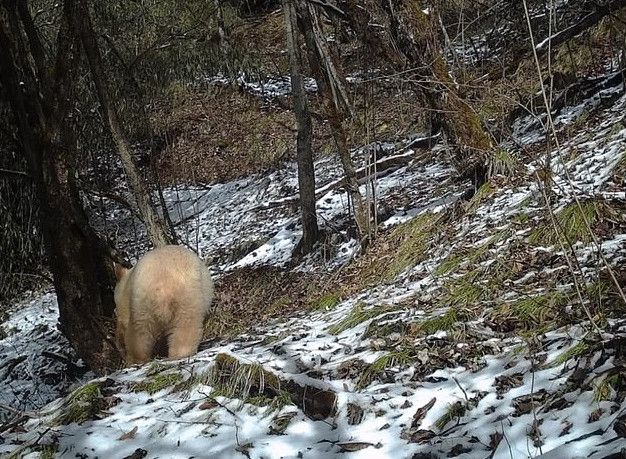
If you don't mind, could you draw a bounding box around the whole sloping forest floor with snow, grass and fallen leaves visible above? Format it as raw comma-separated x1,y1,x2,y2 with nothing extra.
0,50,626,459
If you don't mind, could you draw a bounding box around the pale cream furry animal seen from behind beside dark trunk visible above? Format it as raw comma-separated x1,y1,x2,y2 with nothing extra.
115,245,214,364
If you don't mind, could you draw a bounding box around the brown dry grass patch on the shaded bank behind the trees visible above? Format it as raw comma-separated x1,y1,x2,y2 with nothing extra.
154,87,295,183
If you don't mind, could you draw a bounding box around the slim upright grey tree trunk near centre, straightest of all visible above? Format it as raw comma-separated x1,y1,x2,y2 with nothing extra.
283,0,319,255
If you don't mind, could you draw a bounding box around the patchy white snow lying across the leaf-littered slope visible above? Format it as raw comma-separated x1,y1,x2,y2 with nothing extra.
0,74,626,459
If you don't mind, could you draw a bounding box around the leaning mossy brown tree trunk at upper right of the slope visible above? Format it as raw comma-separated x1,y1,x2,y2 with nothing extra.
340,0,491,187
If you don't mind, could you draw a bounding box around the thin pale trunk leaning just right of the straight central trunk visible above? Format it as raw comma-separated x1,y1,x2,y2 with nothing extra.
295,0,369,239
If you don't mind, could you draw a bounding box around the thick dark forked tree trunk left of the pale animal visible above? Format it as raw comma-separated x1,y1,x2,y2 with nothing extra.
0,3,119,371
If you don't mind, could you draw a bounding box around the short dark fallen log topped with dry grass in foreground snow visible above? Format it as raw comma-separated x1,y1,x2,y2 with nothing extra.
211,353,337,420
